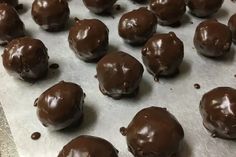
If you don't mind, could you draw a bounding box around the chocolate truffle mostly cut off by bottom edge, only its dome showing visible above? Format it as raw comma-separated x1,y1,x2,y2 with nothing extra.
58,135,118,157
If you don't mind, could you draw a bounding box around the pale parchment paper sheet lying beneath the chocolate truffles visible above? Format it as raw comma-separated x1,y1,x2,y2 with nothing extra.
0,0,236,157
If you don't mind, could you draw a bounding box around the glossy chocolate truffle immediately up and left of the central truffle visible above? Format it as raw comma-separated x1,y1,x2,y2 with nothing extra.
68,19,109,61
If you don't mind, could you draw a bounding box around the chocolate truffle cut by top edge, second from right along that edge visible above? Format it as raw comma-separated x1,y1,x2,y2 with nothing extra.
149,0,186,25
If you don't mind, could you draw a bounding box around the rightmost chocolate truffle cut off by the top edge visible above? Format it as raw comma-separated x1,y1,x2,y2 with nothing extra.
186,0,224,17
